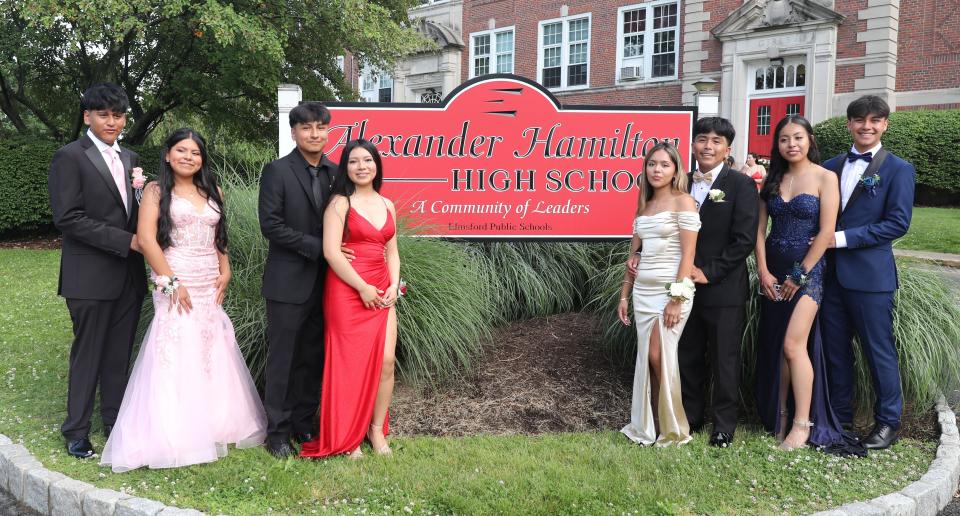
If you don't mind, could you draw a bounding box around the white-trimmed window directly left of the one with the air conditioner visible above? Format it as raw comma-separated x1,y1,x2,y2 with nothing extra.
537,13,590,89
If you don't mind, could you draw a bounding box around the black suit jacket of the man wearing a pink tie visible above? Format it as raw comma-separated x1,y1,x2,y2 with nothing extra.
47,135,147,300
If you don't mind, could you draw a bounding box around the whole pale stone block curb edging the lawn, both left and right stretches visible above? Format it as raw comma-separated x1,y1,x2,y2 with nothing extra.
0,402,960,516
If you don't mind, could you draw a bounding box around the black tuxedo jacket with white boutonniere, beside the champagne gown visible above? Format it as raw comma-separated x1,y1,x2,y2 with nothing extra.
690,165,759,306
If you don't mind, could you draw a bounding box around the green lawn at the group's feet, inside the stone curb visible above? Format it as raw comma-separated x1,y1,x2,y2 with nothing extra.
0,250,935,514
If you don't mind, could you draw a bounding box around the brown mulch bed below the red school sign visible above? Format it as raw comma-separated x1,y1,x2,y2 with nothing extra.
390,313,633,436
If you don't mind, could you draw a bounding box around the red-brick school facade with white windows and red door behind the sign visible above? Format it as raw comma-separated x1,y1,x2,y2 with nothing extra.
461,0,960,161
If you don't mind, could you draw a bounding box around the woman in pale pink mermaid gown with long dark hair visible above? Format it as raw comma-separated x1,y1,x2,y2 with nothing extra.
101,129,266,472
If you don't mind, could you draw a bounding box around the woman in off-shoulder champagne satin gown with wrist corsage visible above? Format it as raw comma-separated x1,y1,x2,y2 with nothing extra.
618,144,700,446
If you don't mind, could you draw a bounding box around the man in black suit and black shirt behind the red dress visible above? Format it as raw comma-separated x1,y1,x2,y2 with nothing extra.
259,102,337,458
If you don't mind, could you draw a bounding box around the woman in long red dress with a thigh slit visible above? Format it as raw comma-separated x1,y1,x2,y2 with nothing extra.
300,140,400,460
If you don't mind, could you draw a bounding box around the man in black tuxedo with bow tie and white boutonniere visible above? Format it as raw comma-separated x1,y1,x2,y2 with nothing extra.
678,117,758,447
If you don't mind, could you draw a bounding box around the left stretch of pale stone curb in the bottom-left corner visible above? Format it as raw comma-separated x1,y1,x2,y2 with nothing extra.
0,434,204,516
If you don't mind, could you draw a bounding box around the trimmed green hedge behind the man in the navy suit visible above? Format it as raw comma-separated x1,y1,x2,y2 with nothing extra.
814,109,960,204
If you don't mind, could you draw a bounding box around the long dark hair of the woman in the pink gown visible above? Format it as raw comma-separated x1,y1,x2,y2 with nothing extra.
157,127,227,254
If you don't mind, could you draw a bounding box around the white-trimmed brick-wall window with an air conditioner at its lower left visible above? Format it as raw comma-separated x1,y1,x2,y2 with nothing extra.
617,0,680,82
